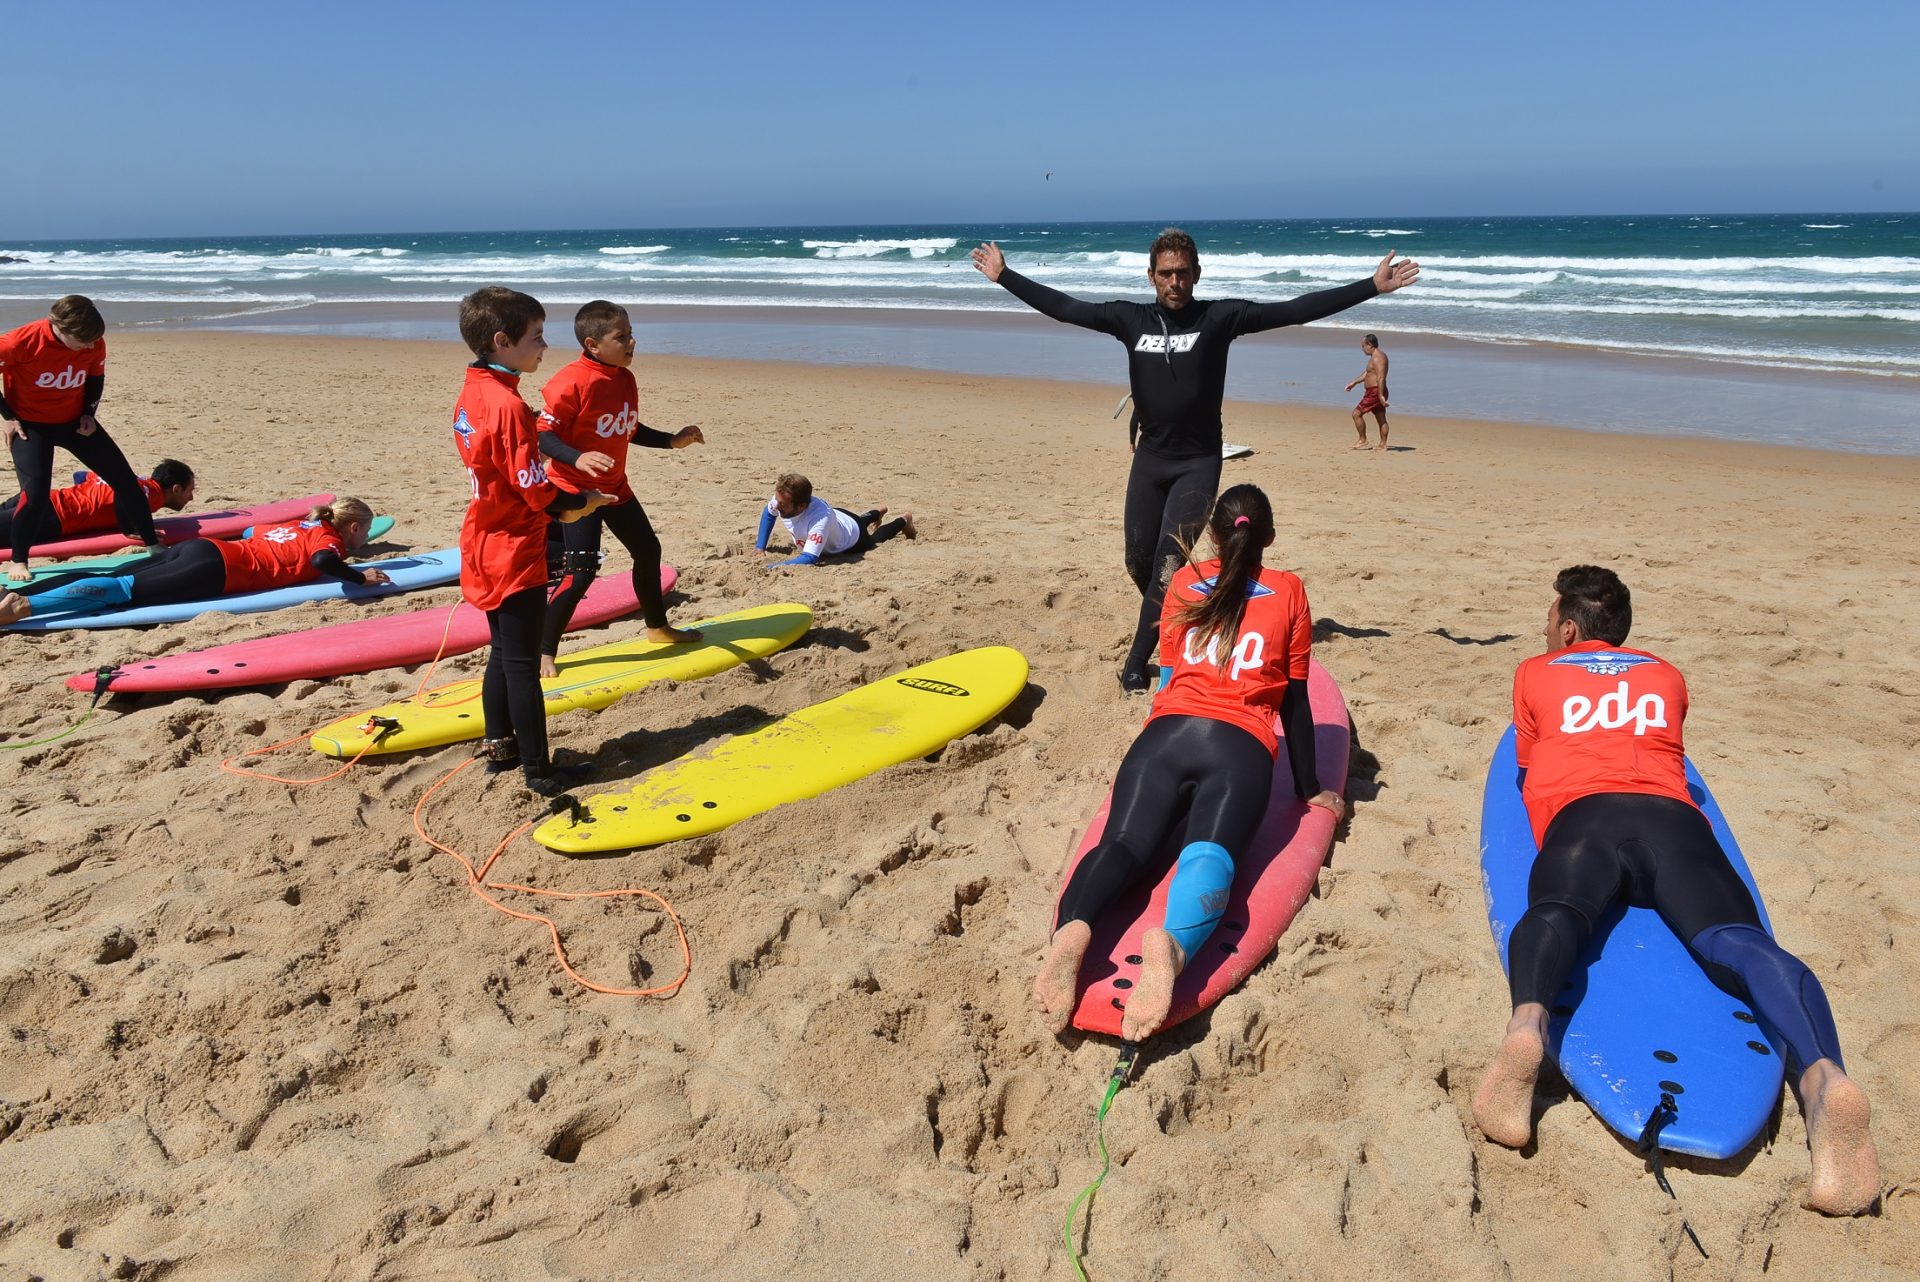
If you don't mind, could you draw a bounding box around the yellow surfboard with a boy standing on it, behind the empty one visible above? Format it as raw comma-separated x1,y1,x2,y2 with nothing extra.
311,603,814,758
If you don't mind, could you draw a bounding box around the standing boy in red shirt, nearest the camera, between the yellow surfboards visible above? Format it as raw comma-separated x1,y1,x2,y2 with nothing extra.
453,286,611,796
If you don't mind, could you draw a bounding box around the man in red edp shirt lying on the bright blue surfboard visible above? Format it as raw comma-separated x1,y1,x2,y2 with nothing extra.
1473,566,1880,1215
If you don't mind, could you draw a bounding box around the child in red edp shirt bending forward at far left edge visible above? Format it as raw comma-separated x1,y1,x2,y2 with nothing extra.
0,294,159,582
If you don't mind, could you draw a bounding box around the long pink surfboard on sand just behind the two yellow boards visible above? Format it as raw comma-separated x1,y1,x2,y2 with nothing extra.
67,564,680,695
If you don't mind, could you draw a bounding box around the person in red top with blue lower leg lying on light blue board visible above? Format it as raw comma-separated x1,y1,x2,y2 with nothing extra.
0,499,388,626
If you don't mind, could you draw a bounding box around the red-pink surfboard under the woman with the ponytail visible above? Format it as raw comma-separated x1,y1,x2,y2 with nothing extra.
1048,664,1352,1036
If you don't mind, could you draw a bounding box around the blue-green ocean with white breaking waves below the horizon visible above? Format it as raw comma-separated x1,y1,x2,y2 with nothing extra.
0,213,1920,382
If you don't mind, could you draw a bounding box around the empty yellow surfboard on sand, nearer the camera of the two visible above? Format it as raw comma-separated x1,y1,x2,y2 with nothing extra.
534,645,1027,854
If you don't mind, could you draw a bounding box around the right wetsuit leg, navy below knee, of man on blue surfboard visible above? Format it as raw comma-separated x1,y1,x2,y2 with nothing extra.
1628,796,1841,1077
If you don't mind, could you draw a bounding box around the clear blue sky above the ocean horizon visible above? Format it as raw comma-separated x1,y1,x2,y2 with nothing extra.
0,0,1920,240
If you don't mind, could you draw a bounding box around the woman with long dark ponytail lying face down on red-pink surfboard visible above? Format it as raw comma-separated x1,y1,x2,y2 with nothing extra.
1033,486,1346,1042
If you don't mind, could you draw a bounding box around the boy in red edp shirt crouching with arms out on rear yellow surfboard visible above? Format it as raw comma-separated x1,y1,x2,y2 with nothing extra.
540,299,707,677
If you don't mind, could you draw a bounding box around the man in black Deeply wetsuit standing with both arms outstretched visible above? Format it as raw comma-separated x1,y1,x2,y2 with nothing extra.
973,226,1421,691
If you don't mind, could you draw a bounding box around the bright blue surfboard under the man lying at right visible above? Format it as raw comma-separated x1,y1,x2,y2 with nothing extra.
1480,725,1786,1157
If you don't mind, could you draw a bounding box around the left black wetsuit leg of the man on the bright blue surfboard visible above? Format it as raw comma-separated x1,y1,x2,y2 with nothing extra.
1507,793,1626,1006
